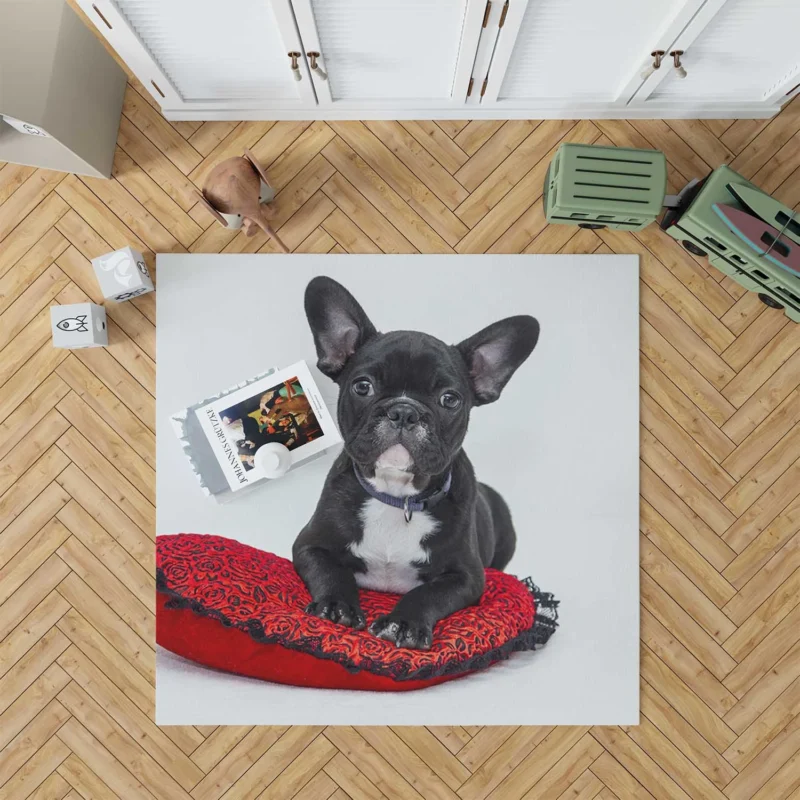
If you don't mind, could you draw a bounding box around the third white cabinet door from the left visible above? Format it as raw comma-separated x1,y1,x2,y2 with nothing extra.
475,0,703,110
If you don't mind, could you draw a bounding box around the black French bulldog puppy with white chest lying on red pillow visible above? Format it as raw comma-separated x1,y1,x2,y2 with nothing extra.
293,277,539,649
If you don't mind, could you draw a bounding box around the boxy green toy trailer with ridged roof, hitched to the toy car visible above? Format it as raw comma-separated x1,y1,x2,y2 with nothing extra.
544,144,667,231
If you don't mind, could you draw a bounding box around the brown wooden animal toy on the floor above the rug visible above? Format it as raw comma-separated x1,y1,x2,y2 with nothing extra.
198,150,289,253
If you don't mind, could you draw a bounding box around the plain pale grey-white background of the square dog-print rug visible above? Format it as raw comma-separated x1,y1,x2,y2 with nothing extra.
156,255,639,725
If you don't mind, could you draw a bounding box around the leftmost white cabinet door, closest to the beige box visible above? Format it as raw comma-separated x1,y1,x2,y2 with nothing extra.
79,0,316,110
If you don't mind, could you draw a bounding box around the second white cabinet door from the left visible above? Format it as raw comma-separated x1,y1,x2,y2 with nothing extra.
292,0,486,110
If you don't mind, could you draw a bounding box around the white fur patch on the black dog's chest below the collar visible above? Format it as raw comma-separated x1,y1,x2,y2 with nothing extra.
350,497,439,594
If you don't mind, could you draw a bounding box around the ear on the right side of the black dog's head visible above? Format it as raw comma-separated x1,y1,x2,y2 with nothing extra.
457,315,539,406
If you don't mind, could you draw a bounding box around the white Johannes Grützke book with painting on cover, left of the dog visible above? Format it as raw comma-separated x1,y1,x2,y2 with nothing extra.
194,361,341,492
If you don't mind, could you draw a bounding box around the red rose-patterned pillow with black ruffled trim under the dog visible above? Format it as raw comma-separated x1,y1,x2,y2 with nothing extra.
156,533,558,691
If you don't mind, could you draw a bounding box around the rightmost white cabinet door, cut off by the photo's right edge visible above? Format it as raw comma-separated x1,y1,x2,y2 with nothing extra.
635,0,800,107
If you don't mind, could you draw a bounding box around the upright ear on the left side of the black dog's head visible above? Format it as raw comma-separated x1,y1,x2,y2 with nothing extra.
305,276,377,380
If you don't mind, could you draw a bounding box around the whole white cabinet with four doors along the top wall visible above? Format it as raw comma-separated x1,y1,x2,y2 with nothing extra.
77,0,800,119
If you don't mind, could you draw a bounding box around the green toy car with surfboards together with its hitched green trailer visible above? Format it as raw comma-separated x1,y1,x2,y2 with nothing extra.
543,144,800,322
